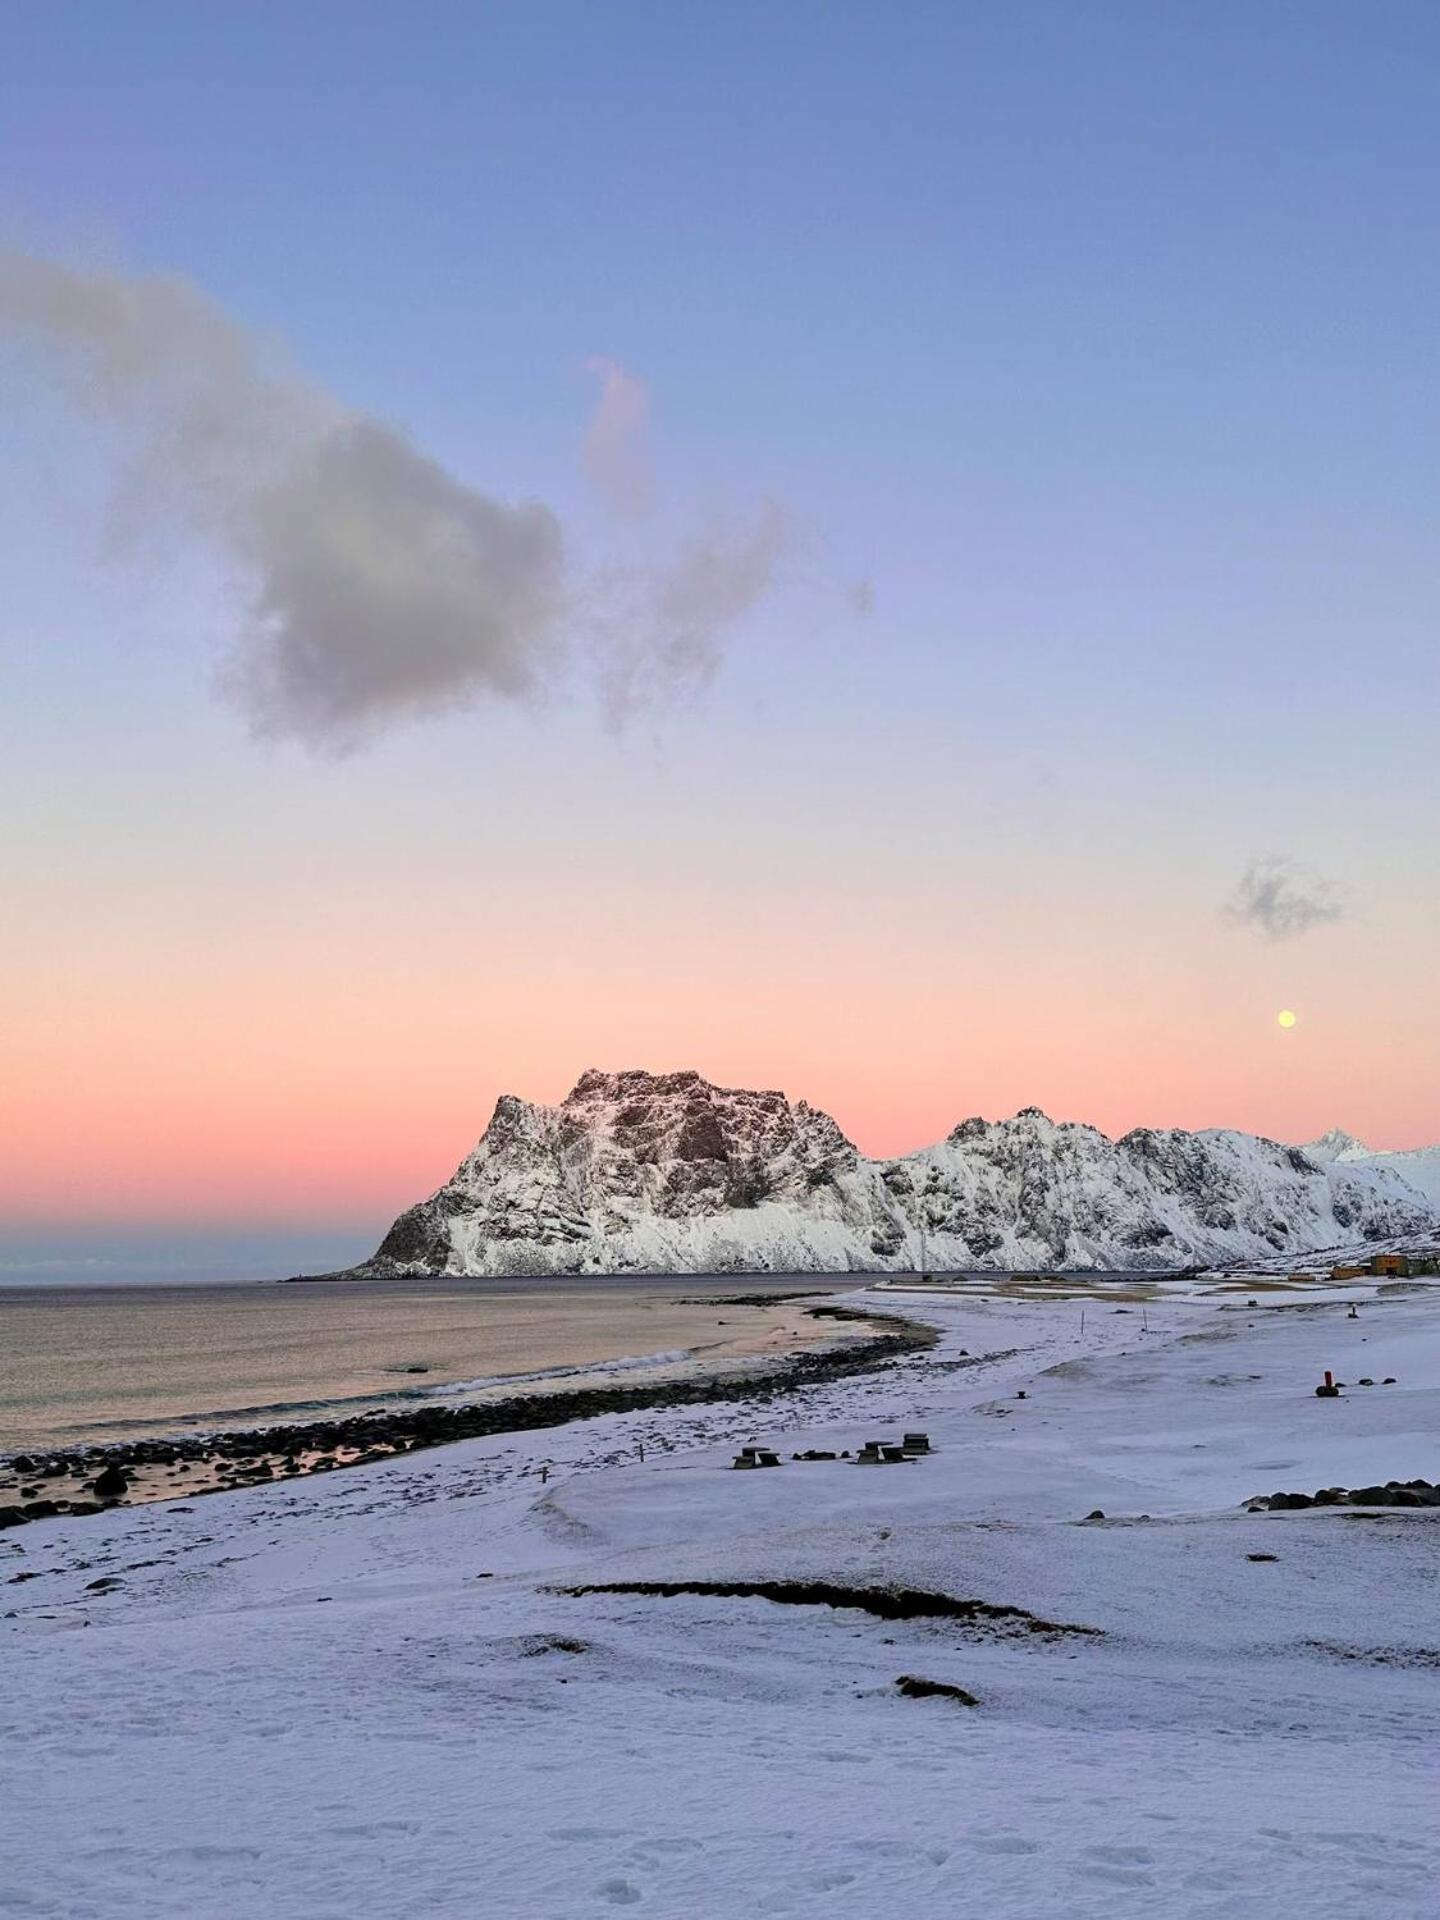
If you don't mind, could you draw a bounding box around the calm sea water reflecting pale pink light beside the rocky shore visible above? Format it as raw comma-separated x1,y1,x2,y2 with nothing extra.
0,1275,860,1450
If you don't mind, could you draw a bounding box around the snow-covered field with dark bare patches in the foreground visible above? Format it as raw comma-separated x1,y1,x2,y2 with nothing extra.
0,1288,1440,1920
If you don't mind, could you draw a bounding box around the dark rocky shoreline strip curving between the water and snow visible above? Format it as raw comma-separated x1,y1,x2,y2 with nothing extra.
0,1306,939,1528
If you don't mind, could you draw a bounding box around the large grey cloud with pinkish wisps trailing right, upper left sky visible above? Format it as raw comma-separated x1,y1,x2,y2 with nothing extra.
0,253,781,751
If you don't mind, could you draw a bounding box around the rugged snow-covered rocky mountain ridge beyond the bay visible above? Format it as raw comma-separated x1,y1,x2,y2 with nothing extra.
341,1069,1440,1277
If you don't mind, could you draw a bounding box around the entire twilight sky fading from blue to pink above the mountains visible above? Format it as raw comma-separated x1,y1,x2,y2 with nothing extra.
0,0,1440,1277
